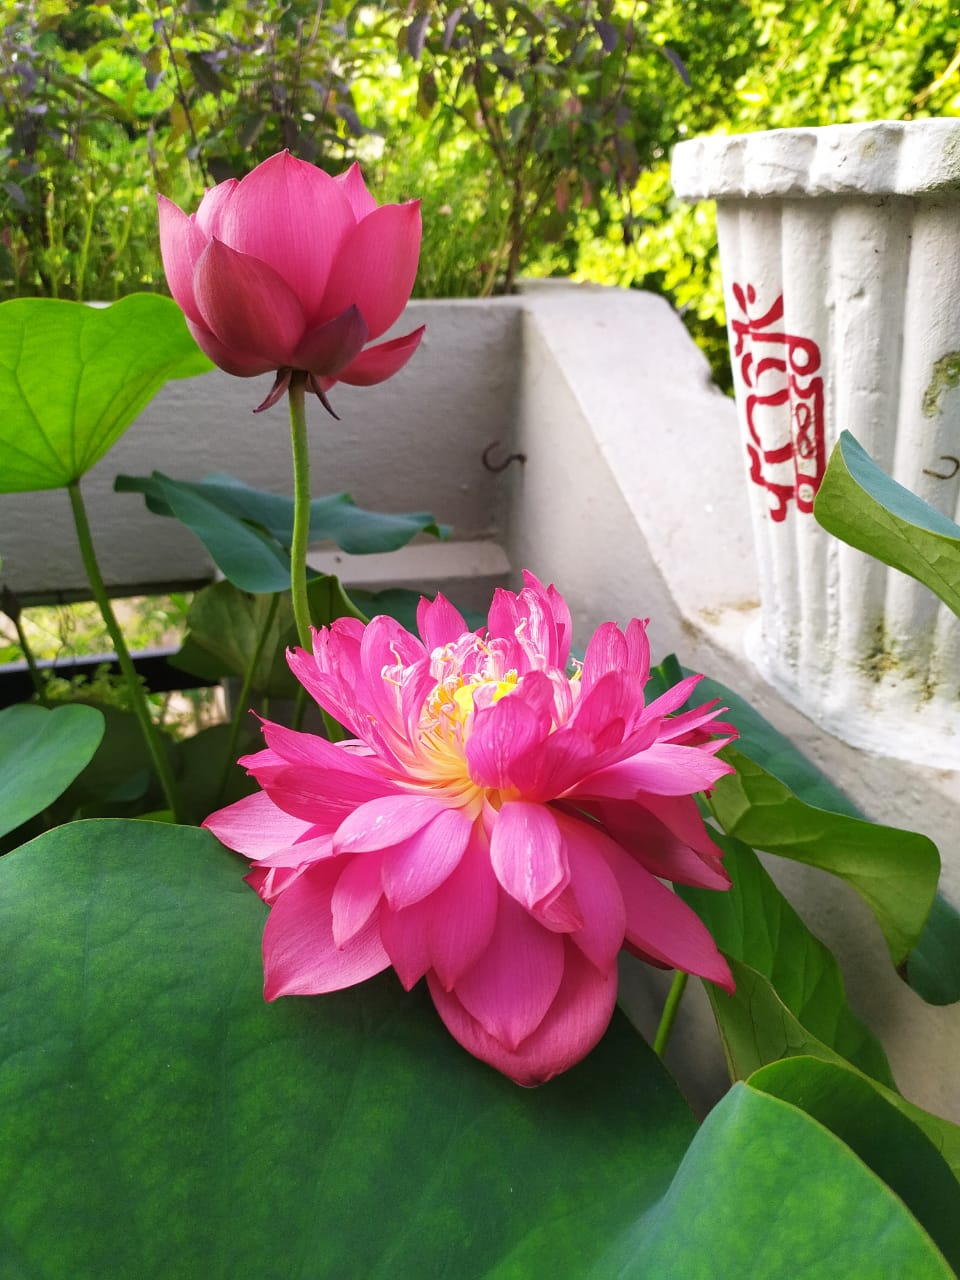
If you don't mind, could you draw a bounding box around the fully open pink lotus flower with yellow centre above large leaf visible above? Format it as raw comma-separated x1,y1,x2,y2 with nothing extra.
205,573,733,1084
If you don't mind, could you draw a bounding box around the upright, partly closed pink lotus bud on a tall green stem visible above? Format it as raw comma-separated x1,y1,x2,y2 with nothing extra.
157,151,424,410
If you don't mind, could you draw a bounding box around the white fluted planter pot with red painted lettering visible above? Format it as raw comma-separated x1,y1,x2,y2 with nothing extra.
673,119,960,768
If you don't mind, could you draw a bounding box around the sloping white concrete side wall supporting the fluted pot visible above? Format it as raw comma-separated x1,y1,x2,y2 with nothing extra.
507,288,960,1121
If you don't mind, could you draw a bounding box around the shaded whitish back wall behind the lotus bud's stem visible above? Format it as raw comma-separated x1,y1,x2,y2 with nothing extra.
0,300,521,603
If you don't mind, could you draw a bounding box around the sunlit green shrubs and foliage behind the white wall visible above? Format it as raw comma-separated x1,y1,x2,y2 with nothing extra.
0,0,960,379
